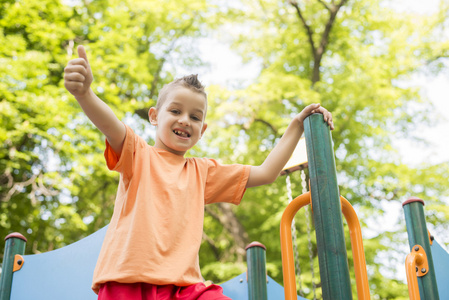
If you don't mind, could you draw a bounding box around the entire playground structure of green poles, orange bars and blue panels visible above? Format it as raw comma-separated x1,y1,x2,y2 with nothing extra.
0,114,449,300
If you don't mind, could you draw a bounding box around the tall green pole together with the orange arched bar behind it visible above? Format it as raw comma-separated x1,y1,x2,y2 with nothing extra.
281,114,369,300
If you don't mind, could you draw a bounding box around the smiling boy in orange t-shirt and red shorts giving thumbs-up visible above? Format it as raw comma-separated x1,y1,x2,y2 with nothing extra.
64,46,333,300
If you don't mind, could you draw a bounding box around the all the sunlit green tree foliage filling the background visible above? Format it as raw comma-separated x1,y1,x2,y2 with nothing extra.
0,0,449,299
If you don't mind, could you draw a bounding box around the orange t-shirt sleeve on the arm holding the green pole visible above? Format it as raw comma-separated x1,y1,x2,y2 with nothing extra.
204,159,251,204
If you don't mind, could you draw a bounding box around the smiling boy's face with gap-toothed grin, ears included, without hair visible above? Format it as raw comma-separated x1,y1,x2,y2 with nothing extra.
148,87,207,155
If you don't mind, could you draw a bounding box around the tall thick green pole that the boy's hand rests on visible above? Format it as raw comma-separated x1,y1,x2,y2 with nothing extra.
304,114,352,300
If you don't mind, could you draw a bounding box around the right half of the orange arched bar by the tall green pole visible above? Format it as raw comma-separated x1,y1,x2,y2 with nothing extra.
340,196,370,300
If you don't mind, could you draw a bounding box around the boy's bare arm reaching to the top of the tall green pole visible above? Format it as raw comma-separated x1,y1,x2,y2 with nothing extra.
246,104,334,187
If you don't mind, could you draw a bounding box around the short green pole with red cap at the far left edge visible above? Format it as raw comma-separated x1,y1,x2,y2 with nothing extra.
0,232,27,300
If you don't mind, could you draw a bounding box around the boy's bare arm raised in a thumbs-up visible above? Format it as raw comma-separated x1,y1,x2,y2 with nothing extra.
64,46,126,155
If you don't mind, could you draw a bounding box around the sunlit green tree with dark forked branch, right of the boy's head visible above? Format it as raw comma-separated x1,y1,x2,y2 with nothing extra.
199,0,449,299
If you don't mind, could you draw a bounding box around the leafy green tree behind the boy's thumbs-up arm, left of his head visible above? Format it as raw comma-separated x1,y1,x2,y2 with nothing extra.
0,0,213,253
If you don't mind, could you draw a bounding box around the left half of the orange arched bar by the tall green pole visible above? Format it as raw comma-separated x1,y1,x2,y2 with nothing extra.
281,192,311,300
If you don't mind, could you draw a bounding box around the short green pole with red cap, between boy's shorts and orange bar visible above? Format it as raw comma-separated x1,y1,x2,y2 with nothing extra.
246,242,268,300
